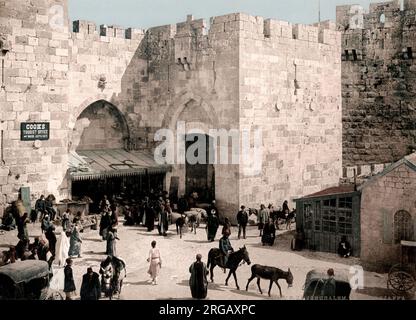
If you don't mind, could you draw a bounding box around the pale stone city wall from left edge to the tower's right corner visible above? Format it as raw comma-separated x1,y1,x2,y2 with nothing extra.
0,0,341,216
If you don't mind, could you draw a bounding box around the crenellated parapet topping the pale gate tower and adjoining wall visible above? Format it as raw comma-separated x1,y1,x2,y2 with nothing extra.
73,12,340,45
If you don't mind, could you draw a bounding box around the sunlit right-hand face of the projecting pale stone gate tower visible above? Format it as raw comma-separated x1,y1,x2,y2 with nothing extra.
240,16,342,207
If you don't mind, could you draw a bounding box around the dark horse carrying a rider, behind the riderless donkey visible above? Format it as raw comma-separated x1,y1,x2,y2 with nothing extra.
207,246,251,290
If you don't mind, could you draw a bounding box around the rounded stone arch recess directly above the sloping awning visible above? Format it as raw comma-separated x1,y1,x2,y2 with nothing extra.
69,99,130,151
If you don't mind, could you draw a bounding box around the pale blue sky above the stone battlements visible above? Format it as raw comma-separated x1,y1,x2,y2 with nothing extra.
68,0,383,29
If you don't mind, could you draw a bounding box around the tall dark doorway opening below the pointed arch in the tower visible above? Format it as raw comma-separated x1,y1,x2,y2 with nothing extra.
185,134,215,203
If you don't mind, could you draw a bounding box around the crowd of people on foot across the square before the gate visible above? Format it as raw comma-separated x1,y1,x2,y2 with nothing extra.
1,190,351,300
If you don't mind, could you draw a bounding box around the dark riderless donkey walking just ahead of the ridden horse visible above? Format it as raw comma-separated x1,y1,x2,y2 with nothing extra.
246,264,293,297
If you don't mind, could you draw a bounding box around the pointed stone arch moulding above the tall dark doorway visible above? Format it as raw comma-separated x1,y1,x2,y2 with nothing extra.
162,90,219,130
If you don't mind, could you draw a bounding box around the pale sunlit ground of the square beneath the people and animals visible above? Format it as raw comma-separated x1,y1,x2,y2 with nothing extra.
0,220,398,300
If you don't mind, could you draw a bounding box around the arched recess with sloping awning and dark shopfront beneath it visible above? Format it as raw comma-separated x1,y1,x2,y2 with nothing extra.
69,100,168,212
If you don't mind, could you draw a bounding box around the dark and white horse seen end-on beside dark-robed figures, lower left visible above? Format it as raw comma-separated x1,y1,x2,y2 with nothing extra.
100,256,127,300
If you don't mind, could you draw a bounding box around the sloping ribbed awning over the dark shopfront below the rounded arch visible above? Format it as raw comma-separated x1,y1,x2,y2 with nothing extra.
68,149,170,181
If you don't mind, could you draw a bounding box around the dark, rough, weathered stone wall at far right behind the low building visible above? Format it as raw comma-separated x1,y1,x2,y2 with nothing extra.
337,0,416,166
